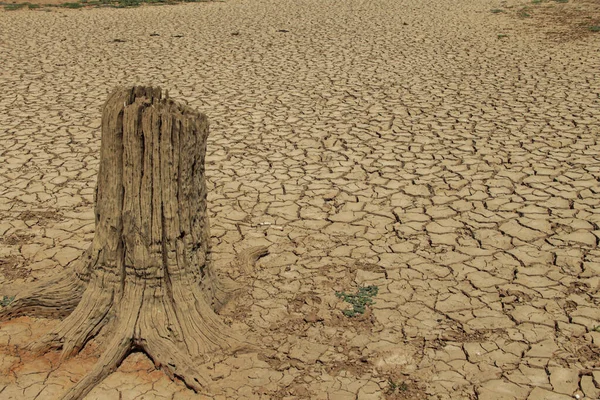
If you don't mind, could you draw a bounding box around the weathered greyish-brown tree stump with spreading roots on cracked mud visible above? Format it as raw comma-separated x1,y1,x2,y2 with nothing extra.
0,87,266,400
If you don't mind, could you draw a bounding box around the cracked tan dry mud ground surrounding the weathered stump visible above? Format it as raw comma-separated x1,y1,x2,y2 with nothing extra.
0,0,600,400
